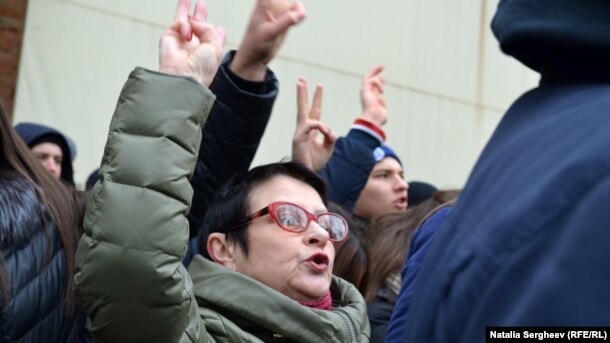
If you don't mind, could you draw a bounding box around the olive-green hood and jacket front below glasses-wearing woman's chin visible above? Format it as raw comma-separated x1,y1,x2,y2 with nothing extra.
189,255,370,343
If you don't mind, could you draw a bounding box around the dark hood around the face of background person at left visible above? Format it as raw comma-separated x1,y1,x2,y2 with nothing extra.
15,123,76,185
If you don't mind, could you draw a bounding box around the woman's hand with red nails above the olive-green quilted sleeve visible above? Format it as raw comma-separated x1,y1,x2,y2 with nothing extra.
159,0,225,87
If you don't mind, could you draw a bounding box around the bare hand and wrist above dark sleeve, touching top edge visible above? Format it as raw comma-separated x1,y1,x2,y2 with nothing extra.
230,0,305,81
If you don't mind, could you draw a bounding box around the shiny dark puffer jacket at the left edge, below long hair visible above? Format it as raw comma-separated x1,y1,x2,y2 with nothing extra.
0,171,84,343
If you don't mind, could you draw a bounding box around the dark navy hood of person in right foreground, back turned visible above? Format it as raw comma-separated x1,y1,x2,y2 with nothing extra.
491,0,610,75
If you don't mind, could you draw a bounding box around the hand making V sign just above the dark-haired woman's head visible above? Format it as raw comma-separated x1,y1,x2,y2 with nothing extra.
292,77,337,171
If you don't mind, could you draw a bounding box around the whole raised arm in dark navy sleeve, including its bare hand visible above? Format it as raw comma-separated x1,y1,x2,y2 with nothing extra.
188,0,305,241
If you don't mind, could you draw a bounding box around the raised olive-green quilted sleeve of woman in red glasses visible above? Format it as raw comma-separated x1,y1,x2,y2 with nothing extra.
75,68,214,343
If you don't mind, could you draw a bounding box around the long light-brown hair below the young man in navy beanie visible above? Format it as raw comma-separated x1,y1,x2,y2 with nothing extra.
364,190,459,302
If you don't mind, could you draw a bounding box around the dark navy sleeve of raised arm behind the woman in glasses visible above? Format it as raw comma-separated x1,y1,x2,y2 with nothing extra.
185,51,278,265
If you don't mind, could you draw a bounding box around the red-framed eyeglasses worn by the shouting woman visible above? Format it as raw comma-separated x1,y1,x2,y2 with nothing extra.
231,201,348,242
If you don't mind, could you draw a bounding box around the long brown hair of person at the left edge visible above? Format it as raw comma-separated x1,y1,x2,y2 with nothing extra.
0,104,83,311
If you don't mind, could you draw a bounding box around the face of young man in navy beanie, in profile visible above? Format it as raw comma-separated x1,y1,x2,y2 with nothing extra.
354,157,409,220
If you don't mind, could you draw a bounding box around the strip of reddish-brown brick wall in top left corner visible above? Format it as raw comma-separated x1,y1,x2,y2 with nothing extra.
0,0,28,118
